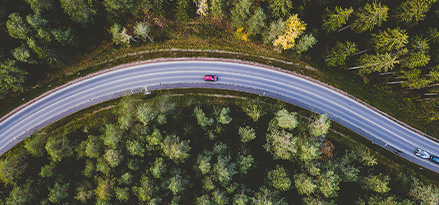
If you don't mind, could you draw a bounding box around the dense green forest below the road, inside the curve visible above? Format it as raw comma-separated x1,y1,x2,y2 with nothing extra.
0,94,439,204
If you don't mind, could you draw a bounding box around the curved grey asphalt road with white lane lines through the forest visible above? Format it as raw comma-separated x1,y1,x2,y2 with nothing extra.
0,59,439,173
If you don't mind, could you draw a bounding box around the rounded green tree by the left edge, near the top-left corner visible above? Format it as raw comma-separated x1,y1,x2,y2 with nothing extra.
6,12,31,40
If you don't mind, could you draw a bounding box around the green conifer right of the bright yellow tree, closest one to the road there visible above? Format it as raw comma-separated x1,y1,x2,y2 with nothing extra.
325,41,358,67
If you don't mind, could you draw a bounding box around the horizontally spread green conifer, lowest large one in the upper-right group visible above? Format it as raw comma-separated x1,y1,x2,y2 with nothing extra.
358,52,400,74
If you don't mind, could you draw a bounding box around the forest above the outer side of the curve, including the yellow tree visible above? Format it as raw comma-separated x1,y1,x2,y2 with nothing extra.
0,0,439,137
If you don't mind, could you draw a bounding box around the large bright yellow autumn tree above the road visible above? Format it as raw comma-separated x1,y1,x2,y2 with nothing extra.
273,14,306,50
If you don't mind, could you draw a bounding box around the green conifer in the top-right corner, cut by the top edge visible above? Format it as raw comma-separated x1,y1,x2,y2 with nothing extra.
395,0,436,26
